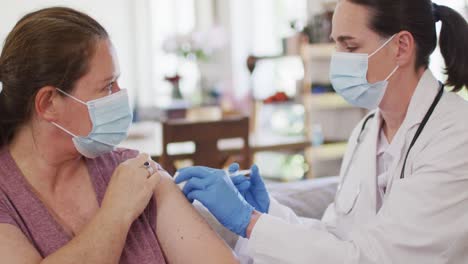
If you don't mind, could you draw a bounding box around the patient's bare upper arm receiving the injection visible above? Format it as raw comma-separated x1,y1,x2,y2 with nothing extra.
154,174,238,264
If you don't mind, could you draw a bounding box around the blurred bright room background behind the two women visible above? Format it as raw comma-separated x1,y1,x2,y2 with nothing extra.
0,0,468,182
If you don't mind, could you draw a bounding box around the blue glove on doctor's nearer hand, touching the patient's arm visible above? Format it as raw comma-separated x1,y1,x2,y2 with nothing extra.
175,167,254,237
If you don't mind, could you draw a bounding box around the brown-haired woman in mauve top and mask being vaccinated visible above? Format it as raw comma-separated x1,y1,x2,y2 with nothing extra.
0,8,236,264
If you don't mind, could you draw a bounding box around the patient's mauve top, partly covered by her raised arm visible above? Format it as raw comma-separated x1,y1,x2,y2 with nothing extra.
0,148,165,264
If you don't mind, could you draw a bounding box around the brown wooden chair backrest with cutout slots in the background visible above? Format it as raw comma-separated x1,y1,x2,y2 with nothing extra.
160,117,251,174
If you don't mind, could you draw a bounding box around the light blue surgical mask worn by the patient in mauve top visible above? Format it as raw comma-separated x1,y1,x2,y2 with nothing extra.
52,89,132,159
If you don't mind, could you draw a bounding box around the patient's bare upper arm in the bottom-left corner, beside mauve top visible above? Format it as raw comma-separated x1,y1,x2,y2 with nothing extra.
0,223,42,264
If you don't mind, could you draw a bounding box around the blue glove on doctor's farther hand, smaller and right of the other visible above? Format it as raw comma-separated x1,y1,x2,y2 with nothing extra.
229,163,270,214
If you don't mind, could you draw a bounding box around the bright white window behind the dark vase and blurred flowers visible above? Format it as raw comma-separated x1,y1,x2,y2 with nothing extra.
136,0,198,107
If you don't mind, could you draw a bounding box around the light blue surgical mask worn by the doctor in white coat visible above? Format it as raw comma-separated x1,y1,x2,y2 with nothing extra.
330,35,399,110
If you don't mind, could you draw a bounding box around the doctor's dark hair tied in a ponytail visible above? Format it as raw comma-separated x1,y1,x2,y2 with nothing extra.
347,0,468,92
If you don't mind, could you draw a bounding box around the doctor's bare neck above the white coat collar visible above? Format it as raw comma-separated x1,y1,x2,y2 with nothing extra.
379,68,425,143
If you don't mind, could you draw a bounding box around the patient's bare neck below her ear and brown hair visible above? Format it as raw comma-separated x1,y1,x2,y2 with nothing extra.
9,122,83,193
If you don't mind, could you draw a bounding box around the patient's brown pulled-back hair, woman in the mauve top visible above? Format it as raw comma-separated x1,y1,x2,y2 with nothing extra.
0,7,108,148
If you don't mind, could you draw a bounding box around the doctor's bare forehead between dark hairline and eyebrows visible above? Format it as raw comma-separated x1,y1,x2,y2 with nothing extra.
330,0,372,41
